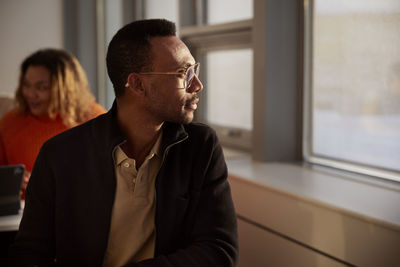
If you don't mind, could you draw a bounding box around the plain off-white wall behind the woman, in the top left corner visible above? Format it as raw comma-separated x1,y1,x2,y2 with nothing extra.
0,0,63,95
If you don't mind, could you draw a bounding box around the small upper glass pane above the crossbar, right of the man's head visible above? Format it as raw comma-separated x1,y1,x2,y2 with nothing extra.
207,0,253,24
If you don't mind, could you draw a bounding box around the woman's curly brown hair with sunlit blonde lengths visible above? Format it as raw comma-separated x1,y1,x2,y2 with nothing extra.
15,49,95,127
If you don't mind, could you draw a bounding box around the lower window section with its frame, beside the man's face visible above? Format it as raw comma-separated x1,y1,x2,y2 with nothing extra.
199,48,253,150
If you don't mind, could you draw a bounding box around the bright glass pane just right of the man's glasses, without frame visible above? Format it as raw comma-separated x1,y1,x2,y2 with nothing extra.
205,49,253,130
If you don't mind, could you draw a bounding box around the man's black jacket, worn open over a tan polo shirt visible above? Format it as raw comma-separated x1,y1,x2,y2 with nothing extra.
10,103,238,267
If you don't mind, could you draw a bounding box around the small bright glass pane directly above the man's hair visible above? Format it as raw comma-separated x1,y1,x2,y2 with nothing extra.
144,0,178,24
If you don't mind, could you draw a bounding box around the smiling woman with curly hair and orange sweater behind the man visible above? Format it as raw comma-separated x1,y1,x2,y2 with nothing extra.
0,49,105,198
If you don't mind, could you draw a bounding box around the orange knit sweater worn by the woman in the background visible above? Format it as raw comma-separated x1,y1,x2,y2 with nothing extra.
0,104,105,172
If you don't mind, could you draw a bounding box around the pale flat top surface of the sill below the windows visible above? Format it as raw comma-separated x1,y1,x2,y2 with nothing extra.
224,148,400,231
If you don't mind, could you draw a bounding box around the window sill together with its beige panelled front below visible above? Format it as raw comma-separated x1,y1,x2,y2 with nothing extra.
224,149,400,266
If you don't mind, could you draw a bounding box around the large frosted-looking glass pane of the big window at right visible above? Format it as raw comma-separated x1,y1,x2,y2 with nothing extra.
312,0,400,171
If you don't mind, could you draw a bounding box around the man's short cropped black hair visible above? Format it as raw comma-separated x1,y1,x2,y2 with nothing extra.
106,19,176,97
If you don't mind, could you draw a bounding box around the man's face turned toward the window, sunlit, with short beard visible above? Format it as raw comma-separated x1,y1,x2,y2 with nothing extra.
143,36,203,123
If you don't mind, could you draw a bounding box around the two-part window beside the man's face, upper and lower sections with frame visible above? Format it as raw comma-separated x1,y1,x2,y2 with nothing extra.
180,0,253,150
